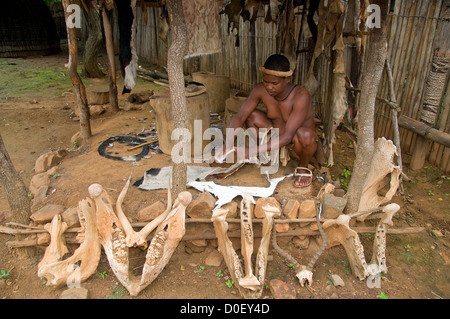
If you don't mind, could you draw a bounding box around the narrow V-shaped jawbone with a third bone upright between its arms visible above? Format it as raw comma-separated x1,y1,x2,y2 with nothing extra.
212,196,281,298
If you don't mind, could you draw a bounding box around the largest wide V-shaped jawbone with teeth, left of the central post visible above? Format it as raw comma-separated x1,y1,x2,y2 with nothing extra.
89,184,192,296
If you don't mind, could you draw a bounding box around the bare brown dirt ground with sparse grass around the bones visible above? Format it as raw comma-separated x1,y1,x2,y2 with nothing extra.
0,53,450,299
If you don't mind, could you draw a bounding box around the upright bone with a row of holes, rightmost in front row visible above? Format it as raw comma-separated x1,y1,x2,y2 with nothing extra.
371,204,400,273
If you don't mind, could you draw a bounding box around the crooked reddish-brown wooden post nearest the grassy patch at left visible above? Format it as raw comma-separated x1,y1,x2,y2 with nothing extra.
62,0,92,140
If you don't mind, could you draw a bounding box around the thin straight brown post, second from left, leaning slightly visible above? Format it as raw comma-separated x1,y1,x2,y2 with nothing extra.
102,6,119,113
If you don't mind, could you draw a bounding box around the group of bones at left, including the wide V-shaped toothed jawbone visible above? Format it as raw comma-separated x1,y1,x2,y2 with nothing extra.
38,179,192,296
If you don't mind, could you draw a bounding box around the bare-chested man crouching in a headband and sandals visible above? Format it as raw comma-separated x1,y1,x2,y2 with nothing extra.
218,54,317,187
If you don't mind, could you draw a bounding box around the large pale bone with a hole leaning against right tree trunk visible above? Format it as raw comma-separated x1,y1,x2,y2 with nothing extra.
357,137,401,221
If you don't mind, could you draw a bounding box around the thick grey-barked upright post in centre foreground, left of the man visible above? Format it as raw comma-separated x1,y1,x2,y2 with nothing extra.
166,0,189,198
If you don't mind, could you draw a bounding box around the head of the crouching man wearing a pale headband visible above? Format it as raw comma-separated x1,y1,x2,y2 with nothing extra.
259,54,293,97
